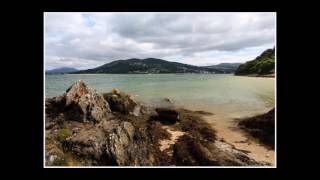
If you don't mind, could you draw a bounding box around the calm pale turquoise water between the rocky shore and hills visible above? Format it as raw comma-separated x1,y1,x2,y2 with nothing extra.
45,74,275,115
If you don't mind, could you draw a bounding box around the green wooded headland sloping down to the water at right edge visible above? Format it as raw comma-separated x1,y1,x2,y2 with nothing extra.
235,48,275,75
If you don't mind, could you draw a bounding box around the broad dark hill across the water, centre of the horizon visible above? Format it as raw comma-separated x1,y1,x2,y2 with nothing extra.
72,58,239,74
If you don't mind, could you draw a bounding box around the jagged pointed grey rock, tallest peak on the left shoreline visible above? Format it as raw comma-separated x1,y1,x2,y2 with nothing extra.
46,80,112,125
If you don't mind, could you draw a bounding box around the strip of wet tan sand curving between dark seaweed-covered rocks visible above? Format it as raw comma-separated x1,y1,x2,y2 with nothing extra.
204,114,275,165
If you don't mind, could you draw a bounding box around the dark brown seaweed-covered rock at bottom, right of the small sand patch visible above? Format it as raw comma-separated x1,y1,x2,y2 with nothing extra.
174,135,267,166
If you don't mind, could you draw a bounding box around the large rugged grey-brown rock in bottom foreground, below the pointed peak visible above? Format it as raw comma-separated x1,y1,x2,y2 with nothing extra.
63,120,153,166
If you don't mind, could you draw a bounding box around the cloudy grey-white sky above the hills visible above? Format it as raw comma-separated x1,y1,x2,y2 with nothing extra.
44,12,276,70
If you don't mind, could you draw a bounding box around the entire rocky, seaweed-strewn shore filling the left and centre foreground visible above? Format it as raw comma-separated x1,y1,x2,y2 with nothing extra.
45,81,263,166
